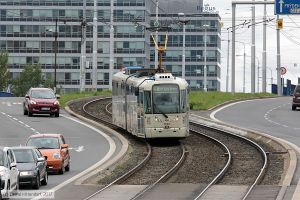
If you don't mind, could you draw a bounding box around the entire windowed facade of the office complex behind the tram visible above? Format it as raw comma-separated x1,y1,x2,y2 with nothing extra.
0,0,220,92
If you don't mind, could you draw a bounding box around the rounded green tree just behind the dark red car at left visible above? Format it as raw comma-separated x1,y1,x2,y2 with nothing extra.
12,65,43,96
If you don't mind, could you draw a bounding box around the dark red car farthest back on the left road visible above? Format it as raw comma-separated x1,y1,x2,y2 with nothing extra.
23,88,60,117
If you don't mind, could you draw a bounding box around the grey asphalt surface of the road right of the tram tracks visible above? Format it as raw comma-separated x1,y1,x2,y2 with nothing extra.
214,97,300,146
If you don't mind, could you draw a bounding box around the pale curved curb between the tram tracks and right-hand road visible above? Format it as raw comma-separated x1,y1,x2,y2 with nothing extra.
190,114,300,200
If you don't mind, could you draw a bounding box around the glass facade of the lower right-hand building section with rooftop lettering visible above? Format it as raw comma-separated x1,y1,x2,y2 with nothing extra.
150,12,221,91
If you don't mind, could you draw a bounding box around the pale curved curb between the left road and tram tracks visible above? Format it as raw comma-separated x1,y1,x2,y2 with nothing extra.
65,106,129,185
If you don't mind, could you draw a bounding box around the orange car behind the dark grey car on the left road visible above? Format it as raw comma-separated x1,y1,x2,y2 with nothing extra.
26,134,70,174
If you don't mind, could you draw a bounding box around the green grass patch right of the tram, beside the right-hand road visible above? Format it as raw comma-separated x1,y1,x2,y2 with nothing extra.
189,92,275,110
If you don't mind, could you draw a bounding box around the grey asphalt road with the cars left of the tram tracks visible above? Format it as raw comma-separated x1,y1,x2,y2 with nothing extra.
0,98,114,197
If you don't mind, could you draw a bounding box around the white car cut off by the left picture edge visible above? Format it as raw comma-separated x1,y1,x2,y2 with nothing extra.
0,147,19,198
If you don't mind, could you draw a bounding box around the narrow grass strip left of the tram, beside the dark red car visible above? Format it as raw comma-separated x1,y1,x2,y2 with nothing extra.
59,90,111,108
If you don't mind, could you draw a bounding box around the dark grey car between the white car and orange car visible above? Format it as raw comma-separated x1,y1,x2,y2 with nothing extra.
11,146,48,190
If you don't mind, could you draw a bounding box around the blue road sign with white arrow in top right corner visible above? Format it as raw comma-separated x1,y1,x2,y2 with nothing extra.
274,0,300,15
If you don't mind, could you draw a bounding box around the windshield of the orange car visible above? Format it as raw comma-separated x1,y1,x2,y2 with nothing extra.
27,137,59,149
